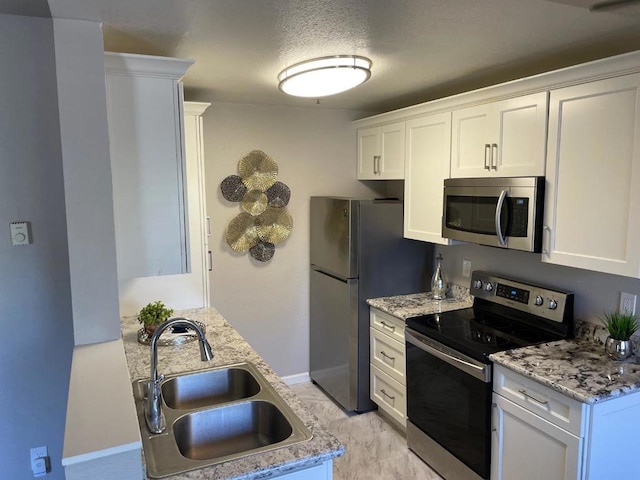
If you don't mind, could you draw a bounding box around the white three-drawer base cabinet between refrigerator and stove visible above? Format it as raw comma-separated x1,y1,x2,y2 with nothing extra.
369,307,407,429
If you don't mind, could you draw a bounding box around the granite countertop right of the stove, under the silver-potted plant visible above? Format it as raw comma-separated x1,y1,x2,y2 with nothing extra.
489,339,640,404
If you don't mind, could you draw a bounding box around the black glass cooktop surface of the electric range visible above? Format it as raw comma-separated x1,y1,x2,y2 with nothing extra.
407,308,564,362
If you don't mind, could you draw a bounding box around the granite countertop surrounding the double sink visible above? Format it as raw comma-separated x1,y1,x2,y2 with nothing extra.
122,308,345,480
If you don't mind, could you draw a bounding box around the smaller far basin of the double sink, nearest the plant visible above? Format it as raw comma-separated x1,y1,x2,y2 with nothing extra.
162,367,260,410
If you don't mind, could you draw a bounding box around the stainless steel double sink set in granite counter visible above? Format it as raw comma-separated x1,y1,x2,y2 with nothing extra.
133,362,311,478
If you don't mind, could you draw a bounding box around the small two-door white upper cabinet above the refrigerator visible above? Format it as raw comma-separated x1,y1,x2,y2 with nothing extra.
358,122,404,180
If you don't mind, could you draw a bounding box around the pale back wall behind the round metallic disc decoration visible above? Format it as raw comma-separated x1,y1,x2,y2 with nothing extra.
204,103,384,375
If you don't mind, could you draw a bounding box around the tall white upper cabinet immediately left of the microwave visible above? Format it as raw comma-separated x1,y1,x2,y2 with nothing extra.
404,112,451,244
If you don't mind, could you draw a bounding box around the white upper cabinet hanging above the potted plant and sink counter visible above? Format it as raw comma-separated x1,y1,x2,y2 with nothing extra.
105,53,193,279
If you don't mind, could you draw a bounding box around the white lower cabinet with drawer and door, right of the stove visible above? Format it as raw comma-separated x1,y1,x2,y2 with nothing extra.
491,365,640,480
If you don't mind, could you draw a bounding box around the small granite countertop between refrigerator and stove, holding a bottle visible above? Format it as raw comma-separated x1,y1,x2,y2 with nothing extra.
367,285,473,320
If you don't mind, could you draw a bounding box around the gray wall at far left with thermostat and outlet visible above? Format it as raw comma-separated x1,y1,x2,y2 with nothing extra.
0,15,74,480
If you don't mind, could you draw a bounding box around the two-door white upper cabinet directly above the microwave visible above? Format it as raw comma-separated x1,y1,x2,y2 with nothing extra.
451,92,548,178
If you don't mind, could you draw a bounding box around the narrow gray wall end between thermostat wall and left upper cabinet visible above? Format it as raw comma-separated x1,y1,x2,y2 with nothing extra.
53,19,120,345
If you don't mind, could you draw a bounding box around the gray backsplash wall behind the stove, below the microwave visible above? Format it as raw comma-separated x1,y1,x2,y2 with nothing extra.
435,244,640,323
